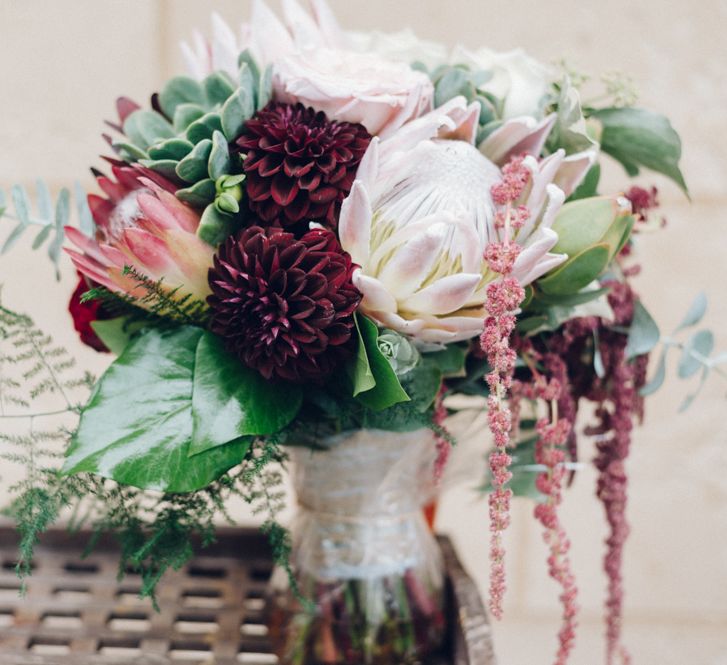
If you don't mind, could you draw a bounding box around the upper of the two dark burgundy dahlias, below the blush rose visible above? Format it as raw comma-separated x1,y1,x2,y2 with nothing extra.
237,102,371,229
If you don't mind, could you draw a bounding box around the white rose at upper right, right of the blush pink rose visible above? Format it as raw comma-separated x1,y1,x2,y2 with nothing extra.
451,46,554,119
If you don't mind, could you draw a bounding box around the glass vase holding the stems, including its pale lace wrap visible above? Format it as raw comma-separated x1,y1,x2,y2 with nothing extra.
269,430,444,665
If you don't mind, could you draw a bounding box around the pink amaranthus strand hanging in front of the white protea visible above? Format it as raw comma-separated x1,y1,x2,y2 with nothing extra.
480,158,529,619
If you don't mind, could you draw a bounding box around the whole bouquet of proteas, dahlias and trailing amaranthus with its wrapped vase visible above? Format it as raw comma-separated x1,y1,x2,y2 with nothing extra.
0,0,712,663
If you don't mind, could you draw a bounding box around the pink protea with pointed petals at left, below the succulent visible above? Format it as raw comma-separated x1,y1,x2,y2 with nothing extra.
66,164,214,304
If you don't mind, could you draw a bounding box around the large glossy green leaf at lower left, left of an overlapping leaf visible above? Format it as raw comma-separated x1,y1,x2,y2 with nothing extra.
63,326,250,492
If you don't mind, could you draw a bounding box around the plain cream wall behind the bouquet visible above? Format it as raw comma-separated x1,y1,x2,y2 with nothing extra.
0,0,727,665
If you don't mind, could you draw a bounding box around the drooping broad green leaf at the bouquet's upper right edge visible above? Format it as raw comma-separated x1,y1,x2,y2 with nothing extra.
592,107,687,193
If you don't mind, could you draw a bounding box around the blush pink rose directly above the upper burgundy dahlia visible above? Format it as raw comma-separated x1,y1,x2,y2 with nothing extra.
273,48,434,137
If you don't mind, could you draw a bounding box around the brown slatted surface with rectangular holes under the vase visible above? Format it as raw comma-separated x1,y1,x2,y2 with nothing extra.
0,529,494,665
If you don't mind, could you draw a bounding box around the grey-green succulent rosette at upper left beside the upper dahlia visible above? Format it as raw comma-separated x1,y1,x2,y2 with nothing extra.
113,52,272,245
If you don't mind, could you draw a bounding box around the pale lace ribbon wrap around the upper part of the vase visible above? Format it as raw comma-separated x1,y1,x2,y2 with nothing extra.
291,430,440,581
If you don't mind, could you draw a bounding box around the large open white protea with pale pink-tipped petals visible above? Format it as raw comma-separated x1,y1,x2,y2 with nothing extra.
339,97,594,344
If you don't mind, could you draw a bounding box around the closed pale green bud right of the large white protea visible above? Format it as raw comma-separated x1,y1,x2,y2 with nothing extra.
537,196,635,296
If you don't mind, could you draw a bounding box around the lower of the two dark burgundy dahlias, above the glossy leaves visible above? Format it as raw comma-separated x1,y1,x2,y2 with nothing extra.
208,226,361,382
